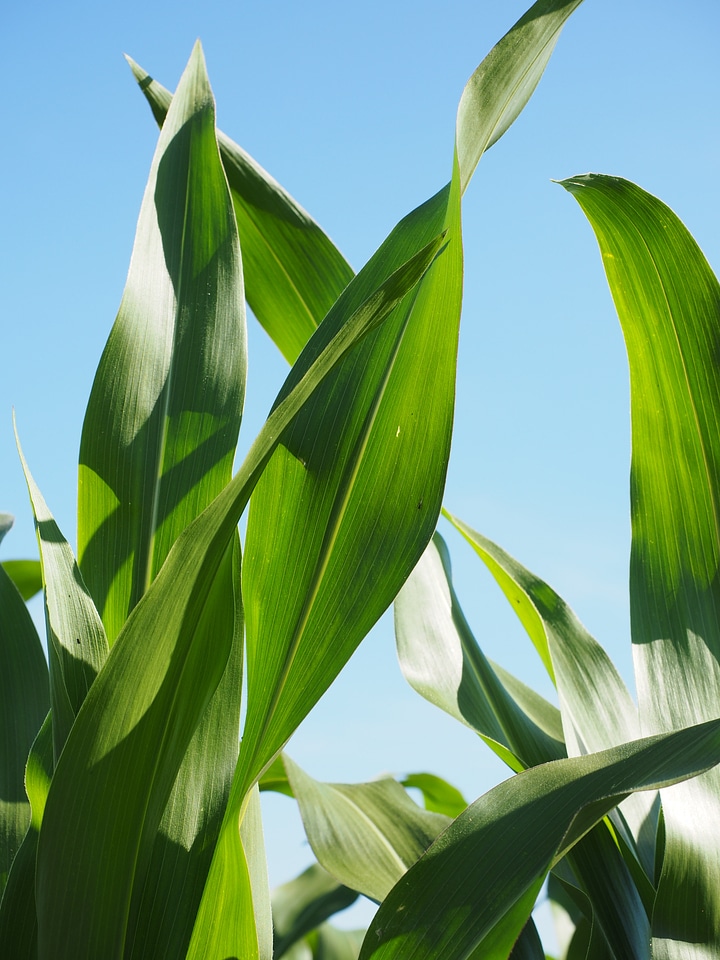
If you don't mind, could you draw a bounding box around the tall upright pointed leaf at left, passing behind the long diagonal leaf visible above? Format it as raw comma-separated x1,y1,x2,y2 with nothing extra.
79,39,247,960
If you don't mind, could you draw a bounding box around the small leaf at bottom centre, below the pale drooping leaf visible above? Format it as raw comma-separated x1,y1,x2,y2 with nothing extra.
272,863,358,958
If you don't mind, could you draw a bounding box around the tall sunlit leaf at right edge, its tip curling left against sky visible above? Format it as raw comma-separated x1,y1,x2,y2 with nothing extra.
563,175,720,960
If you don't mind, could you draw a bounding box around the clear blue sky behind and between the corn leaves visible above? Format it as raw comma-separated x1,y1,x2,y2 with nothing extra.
0,0,720,944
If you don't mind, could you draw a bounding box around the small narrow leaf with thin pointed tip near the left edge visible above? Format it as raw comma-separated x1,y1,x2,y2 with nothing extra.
15,433,108,761
